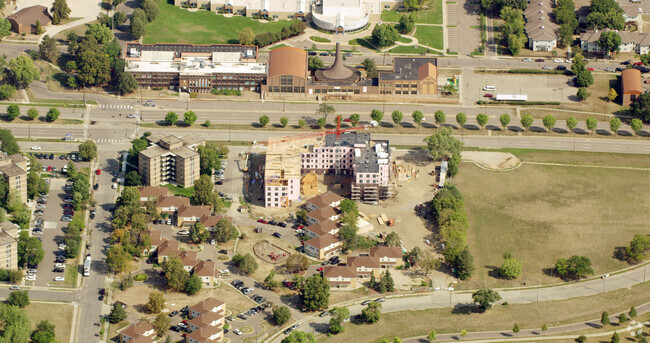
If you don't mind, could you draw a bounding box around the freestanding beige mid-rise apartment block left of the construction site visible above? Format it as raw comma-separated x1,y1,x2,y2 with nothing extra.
138,134,205,187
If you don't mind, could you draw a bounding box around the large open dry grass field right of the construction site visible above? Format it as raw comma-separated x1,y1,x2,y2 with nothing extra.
454,163,650,289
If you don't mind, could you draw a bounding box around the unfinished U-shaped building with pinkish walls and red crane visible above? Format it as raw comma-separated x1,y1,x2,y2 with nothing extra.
264,132,392,207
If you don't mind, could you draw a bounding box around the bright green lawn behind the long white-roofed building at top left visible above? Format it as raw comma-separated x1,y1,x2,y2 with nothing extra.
144,2,291,44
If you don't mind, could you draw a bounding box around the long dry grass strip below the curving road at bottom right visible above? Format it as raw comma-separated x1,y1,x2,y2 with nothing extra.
319,283,650,342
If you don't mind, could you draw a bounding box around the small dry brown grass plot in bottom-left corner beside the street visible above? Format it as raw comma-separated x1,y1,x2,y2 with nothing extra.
25,302,74,343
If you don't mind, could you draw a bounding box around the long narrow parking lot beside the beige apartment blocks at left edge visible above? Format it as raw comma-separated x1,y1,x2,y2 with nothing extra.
30,152,90,287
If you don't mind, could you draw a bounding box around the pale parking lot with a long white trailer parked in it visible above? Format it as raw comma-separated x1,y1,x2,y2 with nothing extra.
463,69,577,104
